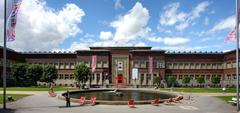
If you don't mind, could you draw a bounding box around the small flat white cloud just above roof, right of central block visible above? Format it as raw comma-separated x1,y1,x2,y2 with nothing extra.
148,37,190,45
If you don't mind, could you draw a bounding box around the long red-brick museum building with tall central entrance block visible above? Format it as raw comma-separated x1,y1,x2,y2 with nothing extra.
0,47,236,86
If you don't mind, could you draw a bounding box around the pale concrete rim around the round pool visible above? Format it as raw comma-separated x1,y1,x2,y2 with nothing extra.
58,88,177,105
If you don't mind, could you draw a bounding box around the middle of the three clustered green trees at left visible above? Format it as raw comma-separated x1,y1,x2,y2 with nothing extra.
26,64,43,86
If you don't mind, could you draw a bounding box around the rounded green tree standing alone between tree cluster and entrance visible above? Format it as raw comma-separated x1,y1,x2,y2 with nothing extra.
74,64,91,87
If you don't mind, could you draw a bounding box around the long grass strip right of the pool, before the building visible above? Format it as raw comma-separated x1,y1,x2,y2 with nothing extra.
160,88,236,93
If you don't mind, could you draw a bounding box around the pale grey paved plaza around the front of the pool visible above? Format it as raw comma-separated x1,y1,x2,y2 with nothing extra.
0,92,236,113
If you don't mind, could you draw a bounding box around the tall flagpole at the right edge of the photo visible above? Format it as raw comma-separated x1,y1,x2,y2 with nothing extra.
236,0,239,111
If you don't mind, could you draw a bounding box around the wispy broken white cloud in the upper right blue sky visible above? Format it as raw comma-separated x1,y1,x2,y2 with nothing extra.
158,1,209,31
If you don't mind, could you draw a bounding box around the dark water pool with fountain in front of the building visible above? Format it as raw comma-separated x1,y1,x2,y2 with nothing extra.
61,88,176,105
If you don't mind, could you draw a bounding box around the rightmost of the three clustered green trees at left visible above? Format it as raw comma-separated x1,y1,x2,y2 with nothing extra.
40,65,57,83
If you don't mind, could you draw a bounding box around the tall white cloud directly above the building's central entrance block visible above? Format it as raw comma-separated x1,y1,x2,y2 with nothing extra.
110,2,151,42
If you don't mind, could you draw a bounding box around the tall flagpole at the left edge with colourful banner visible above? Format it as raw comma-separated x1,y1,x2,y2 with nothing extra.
3,0,7,109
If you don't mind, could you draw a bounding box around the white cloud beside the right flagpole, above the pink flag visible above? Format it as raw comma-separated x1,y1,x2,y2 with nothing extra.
209,15,235,33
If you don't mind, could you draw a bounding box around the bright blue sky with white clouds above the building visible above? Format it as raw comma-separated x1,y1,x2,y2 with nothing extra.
0,0,235,51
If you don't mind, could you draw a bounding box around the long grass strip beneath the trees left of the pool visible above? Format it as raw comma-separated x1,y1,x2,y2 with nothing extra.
0,86,76,91
